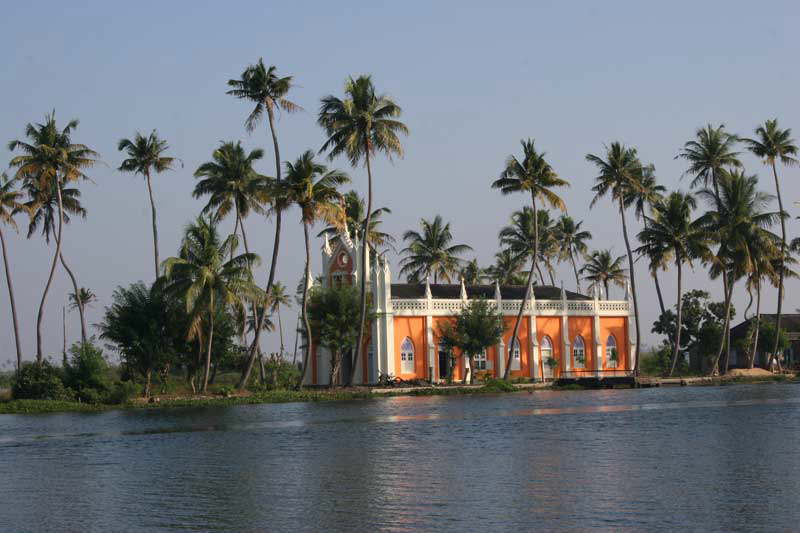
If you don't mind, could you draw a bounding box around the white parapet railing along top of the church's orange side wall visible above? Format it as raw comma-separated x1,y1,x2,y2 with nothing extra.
391,298,630,316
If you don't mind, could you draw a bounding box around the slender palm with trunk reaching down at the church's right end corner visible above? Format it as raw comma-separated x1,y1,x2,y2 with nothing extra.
586,142,642,375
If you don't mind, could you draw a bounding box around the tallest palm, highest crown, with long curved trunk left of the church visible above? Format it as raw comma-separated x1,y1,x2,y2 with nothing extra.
226,58,302,389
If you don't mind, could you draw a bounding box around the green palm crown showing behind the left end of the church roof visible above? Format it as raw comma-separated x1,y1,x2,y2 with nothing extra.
400,215,472,283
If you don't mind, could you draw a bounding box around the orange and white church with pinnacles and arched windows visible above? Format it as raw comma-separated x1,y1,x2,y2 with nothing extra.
306,227,635,385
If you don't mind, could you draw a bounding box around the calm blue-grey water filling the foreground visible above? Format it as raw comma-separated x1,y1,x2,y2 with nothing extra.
0,385,800,531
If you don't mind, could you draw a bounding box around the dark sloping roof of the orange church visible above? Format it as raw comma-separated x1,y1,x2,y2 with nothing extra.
392,283,591,300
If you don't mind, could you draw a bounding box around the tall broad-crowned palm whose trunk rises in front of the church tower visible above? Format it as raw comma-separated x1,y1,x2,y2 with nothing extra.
317,76,408,382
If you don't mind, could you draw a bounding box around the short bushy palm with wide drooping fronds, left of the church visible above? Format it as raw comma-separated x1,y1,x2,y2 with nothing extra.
163,216,263,392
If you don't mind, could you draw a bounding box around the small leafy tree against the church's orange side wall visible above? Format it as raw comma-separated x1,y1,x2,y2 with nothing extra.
439,299,505,383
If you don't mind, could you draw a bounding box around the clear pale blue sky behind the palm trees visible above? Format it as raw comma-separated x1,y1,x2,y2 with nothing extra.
0,1,800,361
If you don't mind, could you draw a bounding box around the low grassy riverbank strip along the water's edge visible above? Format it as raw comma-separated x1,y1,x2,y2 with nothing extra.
0,374,800,415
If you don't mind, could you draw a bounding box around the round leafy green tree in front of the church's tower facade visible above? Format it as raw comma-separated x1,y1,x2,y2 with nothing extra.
308,285,373,387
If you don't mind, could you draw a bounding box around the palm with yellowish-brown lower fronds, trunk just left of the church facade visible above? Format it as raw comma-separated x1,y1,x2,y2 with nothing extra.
284,150,350,385
